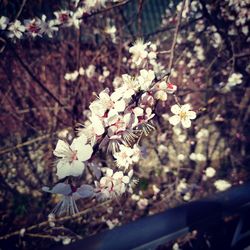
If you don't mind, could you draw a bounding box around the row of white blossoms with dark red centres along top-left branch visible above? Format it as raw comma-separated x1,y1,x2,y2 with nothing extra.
0,0,116,40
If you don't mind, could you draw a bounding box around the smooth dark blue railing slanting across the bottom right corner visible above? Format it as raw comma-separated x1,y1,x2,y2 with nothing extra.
56,183,250,250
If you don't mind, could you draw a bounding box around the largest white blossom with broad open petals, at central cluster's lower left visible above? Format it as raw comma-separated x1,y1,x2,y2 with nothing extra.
53,135,93,179
